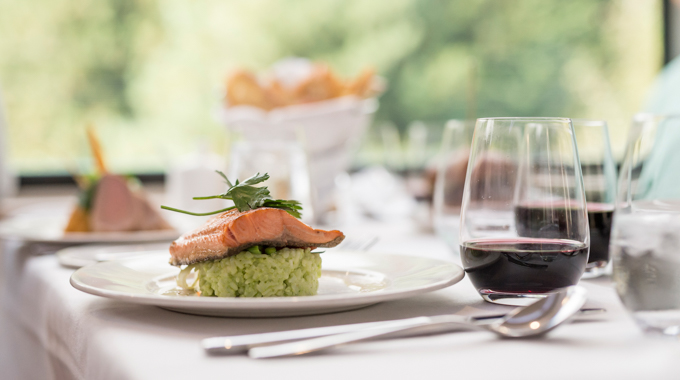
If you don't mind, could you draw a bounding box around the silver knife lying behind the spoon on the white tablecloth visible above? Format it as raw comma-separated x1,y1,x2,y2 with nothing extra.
201,296,606,355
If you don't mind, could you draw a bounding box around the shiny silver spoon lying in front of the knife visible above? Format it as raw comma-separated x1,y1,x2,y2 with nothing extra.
248,286,586,359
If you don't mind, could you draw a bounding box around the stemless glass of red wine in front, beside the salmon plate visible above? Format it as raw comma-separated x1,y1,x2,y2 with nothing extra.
460,118,590,305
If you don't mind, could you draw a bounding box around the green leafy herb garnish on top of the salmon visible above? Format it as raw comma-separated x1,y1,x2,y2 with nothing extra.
161,170,302,219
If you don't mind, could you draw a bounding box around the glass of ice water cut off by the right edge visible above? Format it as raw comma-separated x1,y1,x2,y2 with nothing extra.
610,115,680,336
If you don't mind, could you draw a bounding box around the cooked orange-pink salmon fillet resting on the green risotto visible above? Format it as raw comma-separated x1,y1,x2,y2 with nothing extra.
170,207,345,265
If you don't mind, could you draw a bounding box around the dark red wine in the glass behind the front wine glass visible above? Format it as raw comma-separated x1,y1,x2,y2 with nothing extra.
515,203,614,267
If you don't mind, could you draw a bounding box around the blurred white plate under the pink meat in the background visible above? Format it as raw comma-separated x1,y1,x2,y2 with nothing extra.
0,214,179,244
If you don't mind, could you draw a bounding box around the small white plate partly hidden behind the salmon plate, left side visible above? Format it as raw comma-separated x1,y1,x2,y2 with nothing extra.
56,242,170,268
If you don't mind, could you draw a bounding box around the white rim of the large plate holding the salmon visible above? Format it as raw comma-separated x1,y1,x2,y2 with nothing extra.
69,251,465,311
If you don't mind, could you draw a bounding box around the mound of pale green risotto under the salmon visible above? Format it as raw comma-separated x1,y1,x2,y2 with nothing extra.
178,248,321,297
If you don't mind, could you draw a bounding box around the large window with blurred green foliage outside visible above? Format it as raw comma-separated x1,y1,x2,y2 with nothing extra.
0,0,663,175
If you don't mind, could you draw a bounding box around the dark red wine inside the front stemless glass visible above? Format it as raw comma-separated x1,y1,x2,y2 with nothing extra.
460,238,588,294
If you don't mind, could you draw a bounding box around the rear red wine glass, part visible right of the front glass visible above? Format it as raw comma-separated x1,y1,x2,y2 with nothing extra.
572,119,616,278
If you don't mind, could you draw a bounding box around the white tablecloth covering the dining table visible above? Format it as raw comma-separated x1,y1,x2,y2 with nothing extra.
0,209,680,380
